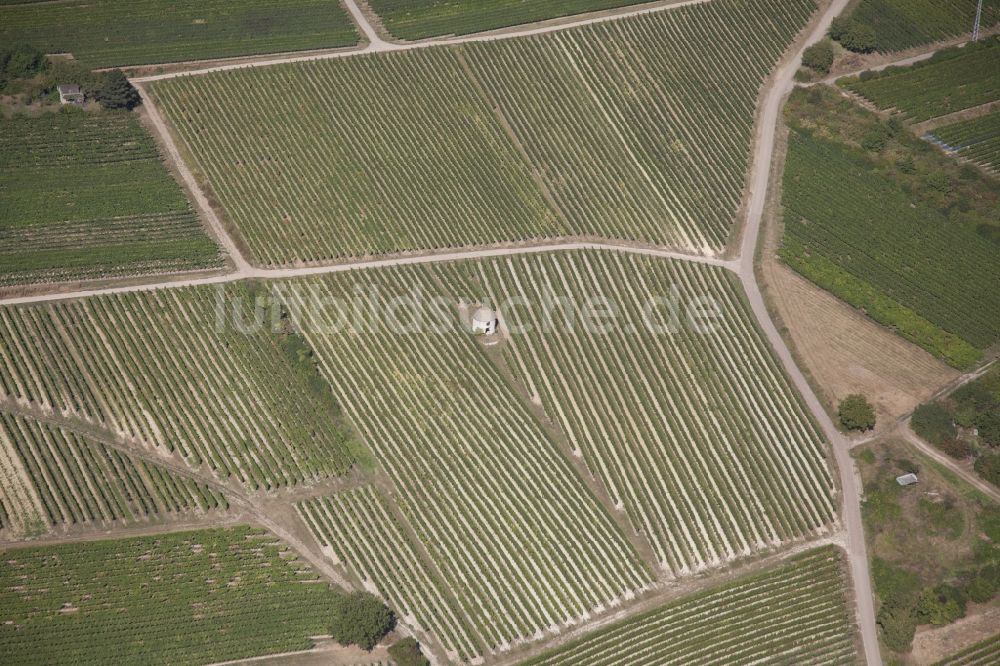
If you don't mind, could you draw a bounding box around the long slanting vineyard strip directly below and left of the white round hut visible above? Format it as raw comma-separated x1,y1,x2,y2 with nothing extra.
281,260,652,651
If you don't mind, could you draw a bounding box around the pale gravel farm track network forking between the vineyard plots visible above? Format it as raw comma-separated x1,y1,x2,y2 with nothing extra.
17,0,996,666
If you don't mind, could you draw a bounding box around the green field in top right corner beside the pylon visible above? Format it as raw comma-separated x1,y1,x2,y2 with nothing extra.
848,0,1000,52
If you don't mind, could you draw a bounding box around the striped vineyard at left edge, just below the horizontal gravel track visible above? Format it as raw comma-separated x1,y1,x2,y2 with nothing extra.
0,284,353,489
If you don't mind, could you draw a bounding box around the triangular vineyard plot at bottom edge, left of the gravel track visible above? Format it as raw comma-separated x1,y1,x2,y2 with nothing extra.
523,546,858,666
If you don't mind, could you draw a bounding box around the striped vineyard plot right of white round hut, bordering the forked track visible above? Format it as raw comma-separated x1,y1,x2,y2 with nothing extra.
440,253,835,575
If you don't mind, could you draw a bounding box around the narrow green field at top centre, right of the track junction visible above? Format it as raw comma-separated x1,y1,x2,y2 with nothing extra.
368,0,643,39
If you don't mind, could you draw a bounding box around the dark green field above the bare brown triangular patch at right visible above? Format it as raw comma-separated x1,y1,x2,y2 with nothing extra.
781,93,1000,368
